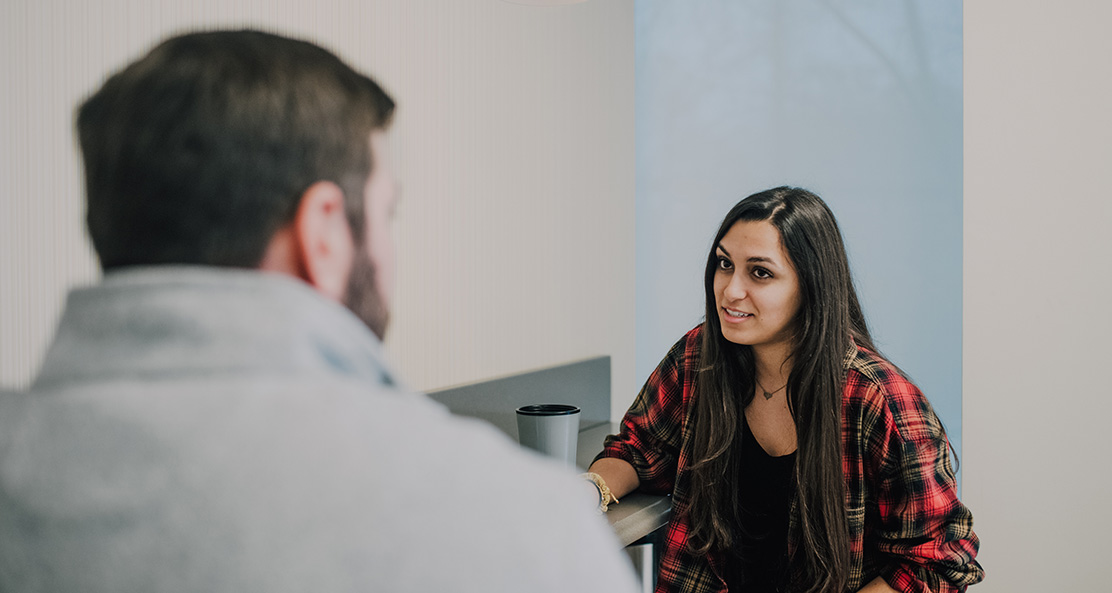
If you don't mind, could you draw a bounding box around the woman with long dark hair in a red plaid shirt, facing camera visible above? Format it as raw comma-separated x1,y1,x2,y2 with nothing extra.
588,187,983,593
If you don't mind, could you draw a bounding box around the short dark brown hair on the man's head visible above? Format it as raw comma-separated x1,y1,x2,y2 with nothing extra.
77,31,394,270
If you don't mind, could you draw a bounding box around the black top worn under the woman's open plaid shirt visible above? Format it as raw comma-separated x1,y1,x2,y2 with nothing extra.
723,423,795,593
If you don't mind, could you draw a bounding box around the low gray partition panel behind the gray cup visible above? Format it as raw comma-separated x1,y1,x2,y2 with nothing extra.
428,356,610,441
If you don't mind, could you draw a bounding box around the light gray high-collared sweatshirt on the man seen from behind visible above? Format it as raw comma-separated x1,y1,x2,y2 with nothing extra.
0,267,635,593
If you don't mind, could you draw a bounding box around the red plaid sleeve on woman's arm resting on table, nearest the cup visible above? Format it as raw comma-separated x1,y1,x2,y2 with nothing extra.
596,329,698,494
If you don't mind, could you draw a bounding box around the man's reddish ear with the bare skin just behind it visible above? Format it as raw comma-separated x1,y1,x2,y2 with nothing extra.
267,181,356,303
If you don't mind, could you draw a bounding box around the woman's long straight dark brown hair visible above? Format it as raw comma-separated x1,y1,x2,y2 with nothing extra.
689,187,875,593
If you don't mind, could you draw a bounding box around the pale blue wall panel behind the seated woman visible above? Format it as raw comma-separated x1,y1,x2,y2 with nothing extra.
636,0,962,471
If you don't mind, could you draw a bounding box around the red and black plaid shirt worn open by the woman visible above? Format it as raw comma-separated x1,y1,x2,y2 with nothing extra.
599,326,984,593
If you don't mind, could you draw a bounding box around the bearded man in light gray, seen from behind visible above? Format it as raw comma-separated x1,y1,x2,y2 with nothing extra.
0,31,634,592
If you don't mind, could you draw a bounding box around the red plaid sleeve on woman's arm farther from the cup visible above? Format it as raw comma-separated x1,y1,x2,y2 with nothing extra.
847,360,984,593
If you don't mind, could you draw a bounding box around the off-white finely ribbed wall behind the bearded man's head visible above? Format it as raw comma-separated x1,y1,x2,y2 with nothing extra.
0,0,634,412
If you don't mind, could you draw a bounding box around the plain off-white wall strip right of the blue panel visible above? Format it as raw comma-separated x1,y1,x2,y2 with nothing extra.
963,0,1112,593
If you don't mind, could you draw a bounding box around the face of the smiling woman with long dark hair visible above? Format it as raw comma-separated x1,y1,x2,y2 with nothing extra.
714,220,800,349
